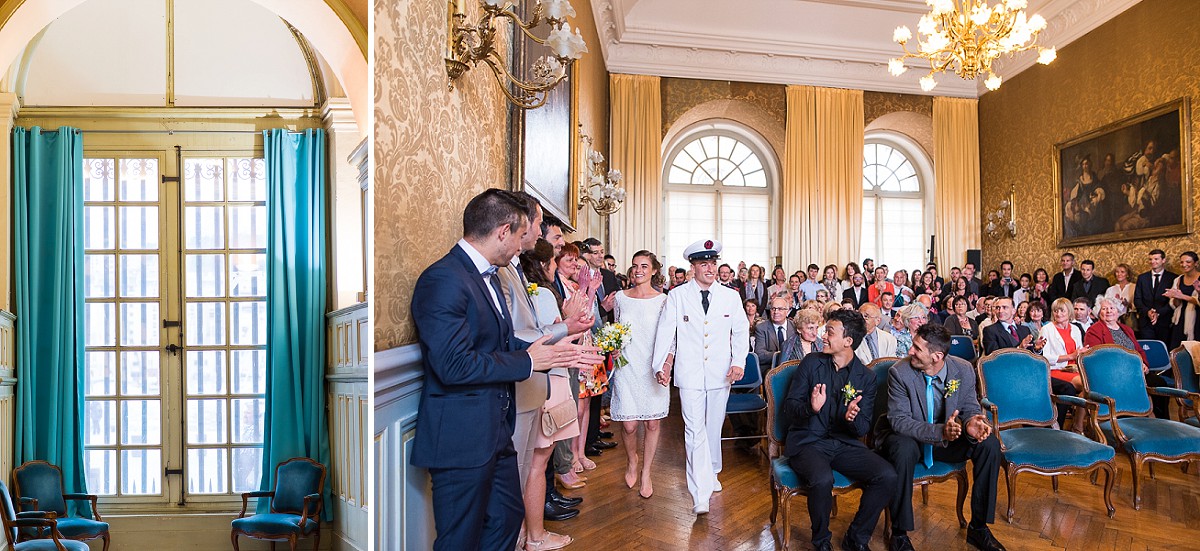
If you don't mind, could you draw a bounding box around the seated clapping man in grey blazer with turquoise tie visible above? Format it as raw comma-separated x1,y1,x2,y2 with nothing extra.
875,324,1004,551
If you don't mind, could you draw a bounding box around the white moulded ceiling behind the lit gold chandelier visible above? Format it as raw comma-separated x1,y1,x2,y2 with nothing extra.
592,0,1140,97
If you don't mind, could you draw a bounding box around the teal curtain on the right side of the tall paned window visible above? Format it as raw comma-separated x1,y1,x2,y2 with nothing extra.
259,128,332,520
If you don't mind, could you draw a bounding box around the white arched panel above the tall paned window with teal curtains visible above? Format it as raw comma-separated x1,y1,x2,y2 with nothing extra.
11,0,322,107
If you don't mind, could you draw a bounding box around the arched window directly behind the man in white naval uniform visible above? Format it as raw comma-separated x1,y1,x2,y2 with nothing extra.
662,124,775,270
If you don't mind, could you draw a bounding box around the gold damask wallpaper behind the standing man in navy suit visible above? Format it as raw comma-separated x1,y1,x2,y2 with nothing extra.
372,0,508,351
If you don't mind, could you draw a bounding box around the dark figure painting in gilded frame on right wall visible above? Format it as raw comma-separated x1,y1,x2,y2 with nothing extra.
1054,98,1192,247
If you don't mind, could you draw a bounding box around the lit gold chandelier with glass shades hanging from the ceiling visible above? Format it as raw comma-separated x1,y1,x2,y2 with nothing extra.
888,0,1057,91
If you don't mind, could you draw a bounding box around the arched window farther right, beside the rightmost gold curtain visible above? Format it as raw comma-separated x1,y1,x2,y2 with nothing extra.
862,136,930,271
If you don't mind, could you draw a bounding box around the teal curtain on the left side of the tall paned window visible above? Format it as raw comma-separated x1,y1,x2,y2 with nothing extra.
12,126,86,508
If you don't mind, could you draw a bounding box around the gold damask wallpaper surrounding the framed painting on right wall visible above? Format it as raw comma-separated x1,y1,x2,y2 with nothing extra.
979,0,1200,276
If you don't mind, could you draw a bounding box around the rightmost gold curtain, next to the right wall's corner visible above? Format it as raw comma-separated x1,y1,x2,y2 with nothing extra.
934,97,980,272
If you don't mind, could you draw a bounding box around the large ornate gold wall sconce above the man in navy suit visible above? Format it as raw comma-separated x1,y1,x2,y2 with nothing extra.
445,0,588,109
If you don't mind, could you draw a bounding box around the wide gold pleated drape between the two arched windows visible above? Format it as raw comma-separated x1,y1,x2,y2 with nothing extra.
780,86,863,271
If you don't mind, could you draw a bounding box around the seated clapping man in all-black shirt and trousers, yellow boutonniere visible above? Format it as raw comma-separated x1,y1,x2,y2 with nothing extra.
782,310,897,551
